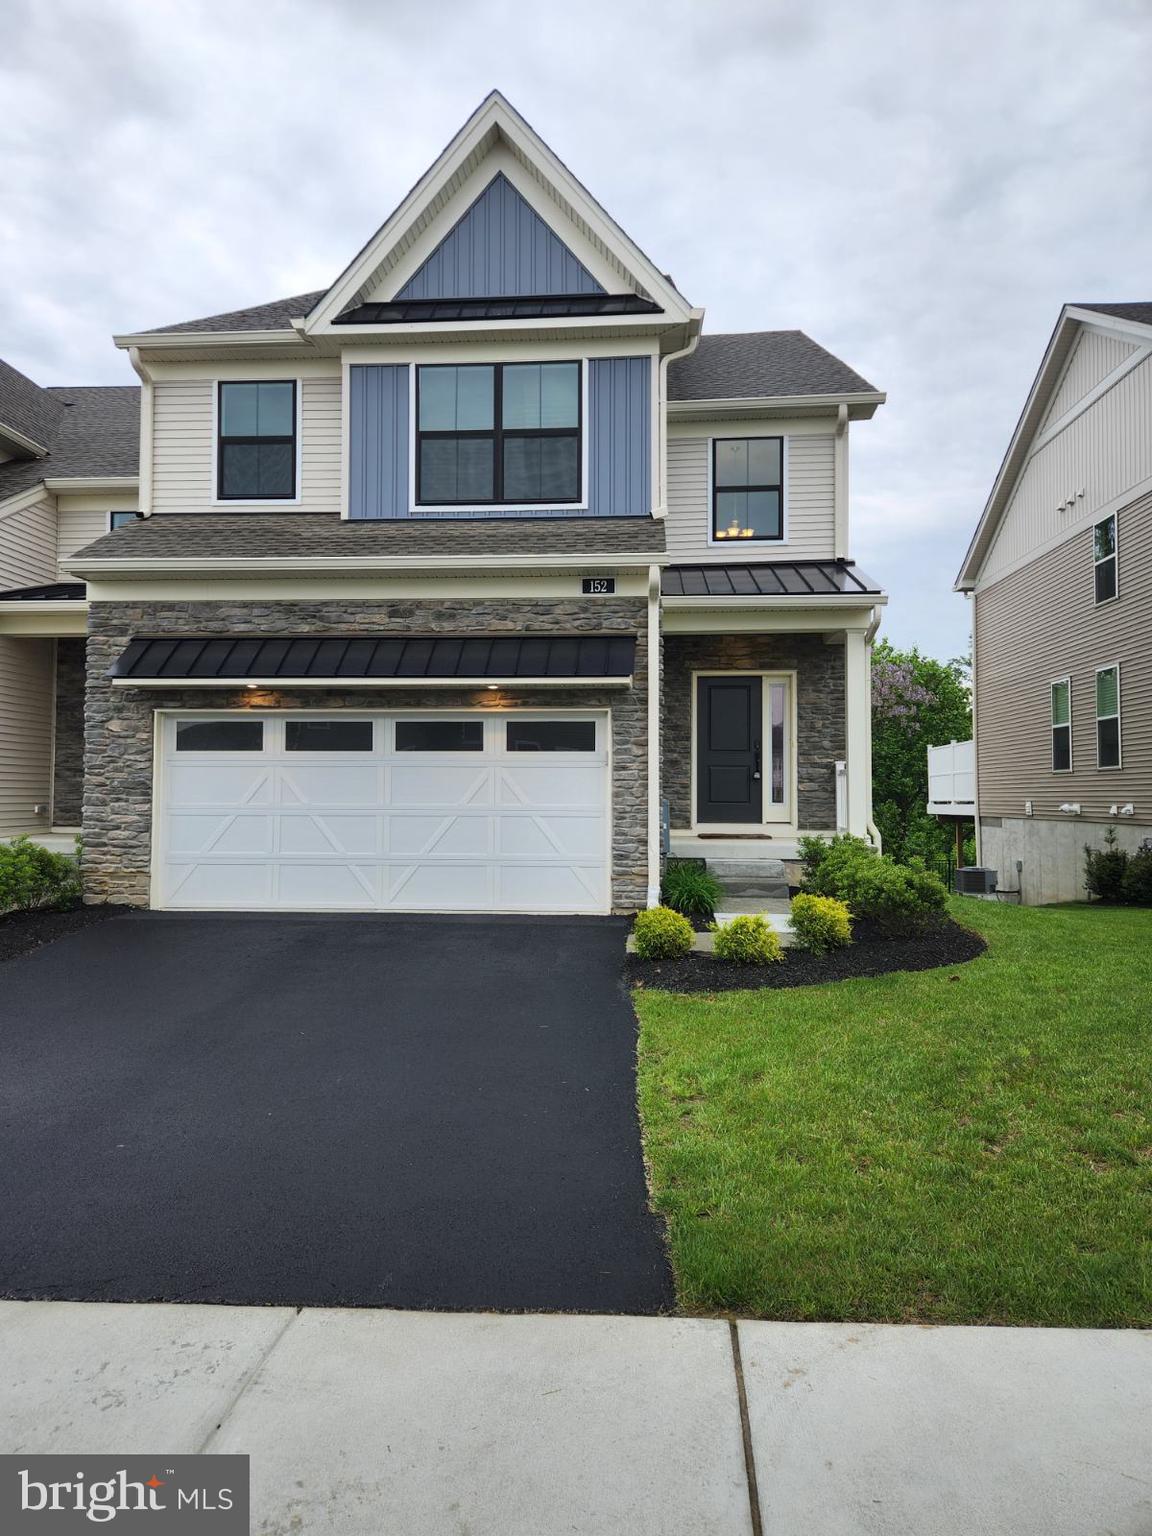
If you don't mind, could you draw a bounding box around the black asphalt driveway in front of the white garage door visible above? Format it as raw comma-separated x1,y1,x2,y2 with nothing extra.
0,914,673,1313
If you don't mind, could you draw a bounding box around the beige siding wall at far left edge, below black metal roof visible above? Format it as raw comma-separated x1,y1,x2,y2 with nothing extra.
0,635,54,837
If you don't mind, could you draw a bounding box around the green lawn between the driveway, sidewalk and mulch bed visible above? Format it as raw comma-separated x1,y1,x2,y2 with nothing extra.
634,899,1152,1327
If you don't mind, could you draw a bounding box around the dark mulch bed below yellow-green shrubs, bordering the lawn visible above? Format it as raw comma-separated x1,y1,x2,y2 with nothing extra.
624,920,988,992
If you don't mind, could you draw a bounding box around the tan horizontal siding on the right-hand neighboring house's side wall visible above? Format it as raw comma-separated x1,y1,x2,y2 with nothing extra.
974,495,1152,826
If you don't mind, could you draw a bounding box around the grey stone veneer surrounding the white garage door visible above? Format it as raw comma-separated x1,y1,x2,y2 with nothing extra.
83,598,648,911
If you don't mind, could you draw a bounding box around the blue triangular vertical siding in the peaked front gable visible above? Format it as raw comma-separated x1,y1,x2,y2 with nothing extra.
395,174,604,300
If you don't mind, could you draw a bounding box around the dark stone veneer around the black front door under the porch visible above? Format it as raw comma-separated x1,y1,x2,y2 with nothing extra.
660,634,845,833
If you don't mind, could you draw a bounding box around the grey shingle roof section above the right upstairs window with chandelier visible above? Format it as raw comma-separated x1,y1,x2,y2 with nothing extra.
668,330,876,399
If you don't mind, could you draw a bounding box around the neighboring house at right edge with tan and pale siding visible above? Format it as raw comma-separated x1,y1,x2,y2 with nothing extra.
957,304,1152,902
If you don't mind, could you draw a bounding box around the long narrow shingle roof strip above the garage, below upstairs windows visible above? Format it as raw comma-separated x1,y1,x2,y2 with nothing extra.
69,511,664,565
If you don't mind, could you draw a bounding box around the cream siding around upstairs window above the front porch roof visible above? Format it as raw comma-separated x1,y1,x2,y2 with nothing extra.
665,422,836,562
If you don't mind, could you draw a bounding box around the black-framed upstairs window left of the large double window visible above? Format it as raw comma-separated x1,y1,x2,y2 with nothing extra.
217,379,296,501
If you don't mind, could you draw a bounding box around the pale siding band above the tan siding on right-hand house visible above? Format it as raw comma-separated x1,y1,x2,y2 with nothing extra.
980,358,1152,588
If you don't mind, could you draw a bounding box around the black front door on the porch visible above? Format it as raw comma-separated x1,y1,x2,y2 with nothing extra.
696,677,763,822
